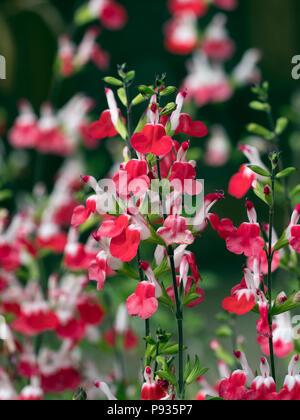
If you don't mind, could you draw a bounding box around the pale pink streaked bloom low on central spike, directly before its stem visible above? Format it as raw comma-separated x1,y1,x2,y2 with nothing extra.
157,216,194,245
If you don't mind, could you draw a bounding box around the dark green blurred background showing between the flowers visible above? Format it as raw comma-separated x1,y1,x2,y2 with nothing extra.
0,0,300,394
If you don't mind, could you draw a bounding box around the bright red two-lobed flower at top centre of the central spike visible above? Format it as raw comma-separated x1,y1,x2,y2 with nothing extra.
131,124,173,156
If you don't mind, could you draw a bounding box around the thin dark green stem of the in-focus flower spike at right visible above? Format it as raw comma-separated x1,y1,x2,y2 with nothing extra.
268,168,276,383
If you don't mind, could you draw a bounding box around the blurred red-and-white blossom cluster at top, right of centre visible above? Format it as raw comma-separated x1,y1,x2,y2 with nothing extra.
165,0,260,106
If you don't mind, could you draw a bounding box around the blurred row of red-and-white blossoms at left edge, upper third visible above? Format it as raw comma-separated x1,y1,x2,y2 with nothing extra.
8,94,95,157
